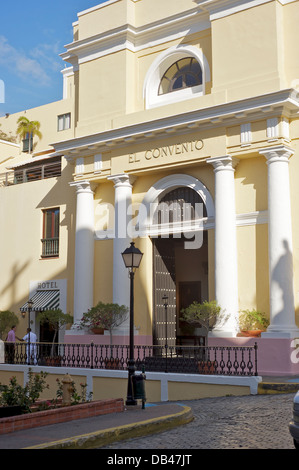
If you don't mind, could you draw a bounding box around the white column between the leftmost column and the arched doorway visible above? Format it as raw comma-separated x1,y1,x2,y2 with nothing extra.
108,174,132,316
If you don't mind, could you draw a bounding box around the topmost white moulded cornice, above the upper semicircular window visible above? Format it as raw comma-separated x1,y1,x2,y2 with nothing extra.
60,8,210,65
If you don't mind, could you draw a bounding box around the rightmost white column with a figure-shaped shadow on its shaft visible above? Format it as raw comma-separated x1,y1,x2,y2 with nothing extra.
259,145,299,338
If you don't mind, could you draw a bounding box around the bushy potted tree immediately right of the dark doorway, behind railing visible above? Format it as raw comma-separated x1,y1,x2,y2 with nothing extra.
182,300,221,373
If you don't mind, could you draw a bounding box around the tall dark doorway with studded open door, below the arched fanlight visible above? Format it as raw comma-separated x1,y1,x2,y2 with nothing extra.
152,232,208,346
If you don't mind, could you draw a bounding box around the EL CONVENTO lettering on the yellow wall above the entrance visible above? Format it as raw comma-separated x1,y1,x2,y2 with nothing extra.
129,140,204,163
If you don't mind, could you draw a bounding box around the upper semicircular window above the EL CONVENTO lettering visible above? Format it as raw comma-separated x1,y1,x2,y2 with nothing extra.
159,57,202,95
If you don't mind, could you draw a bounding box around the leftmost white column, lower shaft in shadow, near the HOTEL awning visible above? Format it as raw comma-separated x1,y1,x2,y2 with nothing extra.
70,181,94,323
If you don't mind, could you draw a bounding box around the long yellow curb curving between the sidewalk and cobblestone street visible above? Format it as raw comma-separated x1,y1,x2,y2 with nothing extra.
25,406,194,449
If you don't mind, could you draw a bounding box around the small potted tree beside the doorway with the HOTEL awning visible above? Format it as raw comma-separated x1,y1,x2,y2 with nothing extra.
37,308,73,365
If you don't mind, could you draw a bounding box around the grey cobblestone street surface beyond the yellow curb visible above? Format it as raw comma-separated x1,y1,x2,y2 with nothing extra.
107,394,294,450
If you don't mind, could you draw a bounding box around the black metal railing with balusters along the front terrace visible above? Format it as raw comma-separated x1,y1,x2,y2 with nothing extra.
5,343,258,376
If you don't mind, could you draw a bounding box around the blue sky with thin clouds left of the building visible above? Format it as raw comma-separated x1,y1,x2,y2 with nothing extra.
0,0,103,116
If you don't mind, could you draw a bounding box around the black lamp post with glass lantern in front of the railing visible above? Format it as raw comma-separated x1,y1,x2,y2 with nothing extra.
122,242,143,406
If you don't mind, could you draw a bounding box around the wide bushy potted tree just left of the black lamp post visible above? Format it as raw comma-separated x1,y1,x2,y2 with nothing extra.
77,302,129,368
